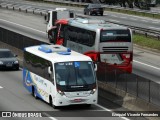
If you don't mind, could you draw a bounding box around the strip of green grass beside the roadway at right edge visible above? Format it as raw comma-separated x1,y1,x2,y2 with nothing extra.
133,34,160,50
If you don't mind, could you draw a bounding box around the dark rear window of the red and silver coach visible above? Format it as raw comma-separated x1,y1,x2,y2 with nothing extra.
100,30,131,42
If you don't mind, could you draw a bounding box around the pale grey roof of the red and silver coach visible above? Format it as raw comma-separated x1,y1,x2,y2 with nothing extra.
68,18,128,31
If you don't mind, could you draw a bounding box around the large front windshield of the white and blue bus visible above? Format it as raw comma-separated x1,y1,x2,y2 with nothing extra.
55,61,96,89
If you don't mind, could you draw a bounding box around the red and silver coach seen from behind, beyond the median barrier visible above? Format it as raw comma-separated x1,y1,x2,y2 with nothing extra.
48,18,133,73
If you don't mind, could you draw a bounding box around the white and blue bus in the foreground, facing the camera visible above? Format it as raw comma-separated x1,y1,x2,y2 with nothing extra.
23,45,98,108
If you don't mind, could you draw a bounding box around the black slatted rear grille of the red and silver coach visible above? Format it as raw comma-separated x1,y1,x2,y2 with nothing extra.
102,47,128,52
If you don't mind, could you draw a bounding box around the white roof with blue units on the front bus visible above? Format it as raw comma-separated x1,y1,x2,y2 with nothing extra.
25,45,92,63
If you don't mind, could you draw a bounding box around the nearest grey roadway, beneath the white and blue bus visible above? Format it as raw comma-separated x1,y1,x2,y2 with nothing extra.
0,70,134,120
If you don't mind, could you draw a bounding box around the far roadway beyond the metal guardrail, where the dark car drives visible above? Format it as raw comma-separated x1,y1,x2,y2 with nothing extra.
2,0,160,31
